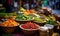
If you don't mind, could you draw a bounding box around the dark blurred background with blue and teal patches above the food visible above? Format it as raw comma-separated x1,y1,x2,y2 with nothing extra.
0,0,60,14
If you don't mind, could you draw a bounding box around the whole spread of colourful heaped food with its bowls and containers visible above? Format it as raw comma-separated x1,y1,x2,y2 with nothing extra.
0,8,60,36
